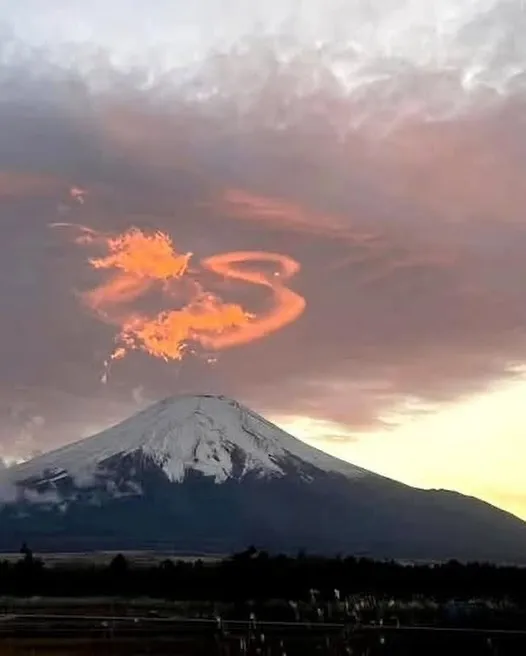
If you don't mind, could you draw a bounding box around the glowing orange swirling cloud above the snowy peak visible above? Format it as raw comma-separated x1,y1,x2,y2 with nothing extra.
55,224,305,374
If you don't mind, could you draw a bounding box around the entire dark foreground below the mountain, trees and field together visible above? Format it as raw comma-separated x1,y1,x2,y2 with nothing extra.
0,550,526,656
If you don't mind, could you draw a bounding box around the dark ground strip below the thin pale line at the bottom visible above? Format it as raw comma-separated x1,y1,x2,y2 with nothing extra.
0,609,526,656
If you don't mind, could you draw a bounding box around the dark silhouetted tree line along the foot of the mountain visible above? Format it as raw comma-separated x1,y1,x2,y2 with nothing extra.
0,545,526,605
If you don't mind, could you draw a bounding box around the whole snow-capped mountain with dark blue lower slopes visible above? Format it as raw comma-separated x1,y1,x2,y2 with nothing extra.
0,395,526,562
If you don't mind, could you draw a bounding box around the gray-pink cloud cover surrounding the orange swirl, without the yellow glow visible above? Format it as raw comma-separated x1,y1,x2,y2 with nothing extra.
0,0,526,455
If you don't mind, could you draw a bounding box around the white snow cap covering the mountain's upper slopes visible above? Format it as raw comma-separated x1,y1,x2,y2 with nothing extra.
0,395,370,497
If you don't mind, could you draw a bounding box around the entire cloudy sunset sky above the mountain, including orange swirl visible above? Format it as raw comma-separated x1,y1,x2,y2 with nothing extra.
0,0,526,519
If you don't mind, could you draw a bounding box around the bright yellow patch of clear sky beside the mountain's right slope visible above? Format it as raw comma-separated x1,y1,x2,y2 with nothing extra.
271,380,526,520
